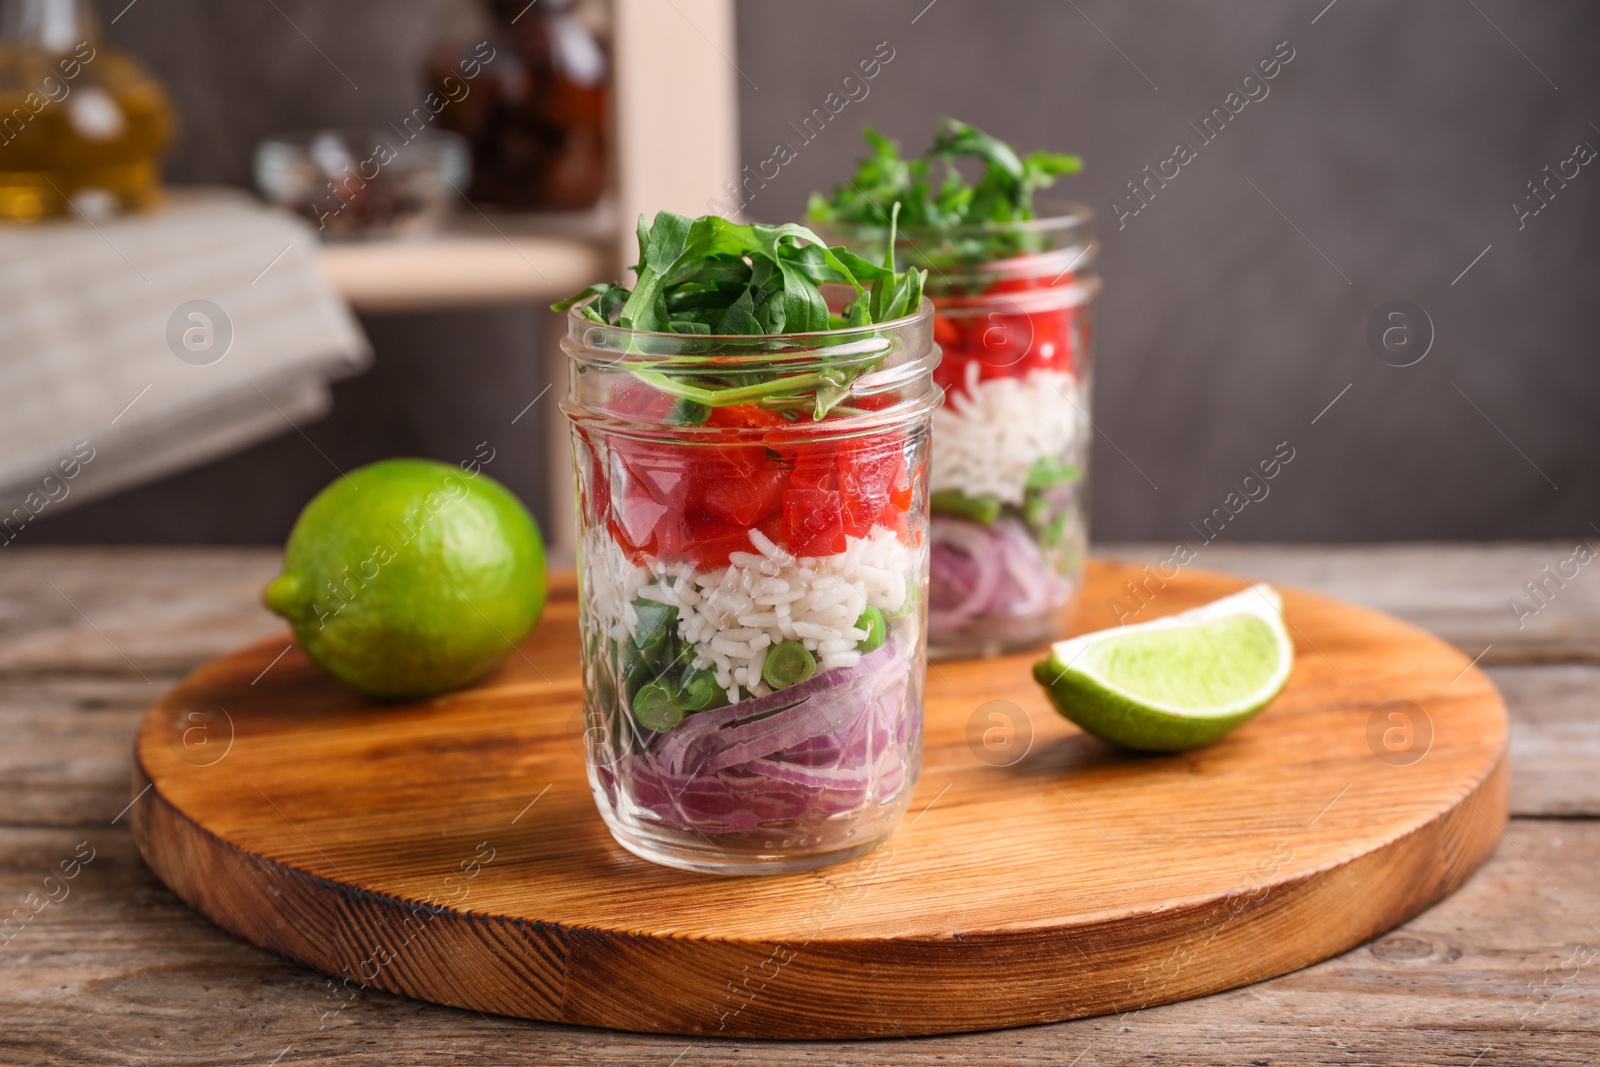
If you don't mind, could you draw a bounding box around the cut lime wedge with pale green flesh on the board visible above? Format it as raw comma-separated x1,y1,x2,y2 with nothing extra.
1034,584,1294,752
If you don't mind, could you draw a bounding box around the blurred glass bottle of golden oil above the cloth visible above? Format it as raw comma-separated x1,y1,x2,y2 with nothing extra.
0,0,173,222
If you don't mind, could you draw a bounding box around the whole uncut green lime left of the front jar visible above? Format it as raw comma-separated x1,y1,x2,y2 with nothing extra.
261,459,544,699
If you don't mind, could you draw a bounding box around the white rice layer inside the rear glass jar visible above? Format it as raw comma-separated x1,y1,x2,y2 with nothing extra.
930,363,1086,504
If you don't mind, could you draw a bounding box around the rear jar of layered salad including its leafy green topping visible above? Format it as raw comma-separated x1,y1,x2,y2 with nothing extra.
808,120,1099,657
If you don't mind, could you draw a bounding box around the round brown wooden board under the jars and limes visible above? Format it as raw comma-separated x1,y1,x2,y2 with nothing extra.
133,563,1507,1038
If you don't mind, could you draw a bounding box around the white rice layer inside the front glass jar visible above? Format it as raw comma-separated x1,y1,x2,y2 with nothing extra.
584,528,914,702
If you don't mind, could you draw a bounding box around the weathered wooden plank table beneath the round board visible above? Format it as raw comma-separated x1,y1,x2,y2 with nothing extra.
0,544,1600,1067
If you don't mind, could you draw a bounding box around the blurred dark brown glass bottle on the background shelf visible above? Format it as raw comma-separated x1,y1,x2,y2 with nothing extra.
429,0,610,210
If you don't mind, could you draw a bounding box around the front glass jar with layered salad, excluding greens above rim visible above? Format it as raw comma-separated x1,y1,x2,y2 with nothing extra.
562,294,939,873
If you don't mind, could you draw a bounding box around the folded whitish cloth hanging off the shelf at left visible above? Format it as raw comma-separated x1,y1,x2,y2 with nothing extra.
0,190,371,531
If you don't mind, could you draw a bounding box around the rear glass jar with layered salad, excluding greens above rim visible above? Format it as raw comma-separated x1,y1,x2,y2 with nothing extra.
816,203,1099,659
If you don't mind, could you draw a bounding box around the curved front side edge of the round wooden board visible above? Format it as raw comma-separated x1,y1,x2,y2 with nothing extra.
133,729,1509,1040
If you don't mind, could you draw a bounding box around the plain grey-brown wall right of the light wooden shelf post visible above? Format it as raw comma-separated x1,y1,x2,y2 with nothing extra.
739,0,1600,541
